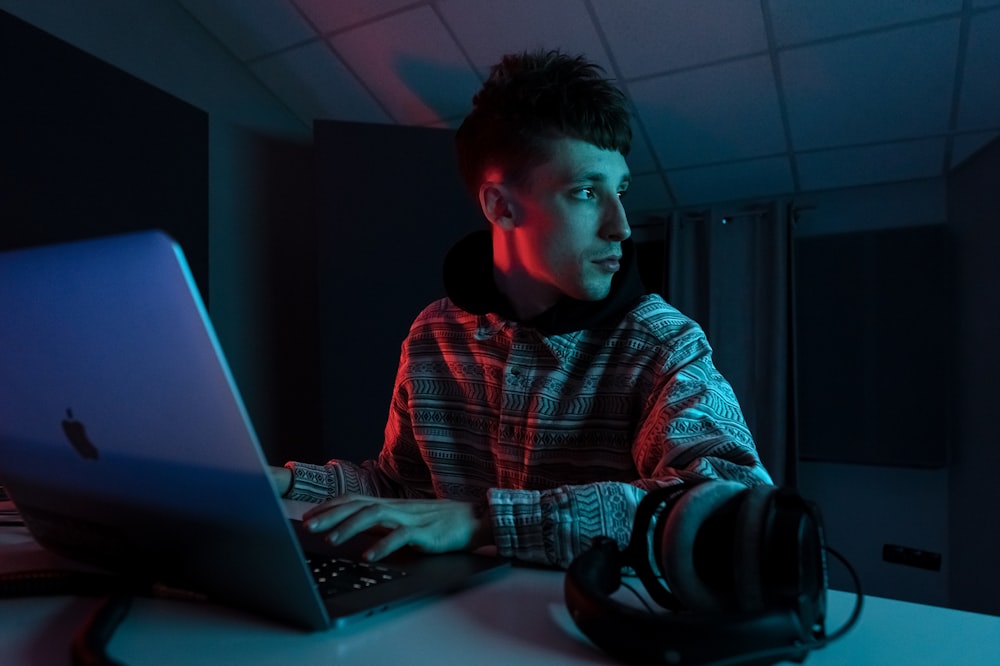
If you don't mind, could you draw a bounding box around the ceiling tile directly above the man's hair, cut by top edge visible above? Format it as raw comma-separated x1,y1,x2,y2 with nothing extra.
437,0,613,79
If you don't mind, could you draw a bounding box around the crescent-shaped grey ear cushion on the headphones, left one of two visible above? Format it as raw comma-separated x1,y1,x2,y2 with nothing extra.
659,481,747,611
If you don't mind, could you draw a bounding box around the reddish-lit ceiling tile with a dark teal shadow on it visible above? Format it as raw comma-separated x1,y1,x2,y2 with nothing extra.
330,7,480,125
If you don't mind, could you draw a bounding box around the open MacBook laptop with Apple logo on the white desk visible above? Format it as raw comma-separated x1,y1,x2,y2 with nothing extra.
0,231,509,630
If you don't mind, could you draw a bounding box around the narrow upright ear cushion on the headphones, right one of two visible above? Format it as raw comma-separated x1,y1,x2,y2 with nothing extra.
733,486,776,611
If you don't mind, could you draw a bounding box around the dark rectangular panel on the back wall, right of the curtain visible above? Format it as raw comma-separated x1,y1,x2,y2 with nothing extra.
796,225,955,467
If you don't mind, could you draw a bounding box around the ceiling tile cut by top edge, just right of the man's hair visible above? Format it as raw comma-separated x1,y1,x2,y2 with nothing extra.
591,0,767,79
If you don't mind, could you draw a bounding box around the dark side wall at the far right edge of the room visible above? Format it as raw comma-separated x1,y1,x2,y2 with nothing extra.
940,141,1000,615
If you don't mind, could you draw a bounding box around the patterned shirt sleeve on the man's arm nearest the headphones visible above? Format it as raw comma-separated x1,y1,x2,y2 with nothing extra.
489,336,772,568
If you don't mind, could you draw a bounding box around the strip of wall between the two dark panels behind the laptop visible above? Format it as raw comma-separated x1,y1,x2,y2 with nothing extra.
210,124,322,464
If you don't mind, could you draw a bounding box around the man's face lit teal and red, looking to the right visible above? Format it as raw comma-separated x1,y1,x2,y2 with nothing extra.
494,138,631,317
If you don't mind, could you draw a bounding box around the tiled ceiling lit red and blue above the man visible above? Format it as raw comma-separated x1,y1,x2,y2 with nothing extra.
177,0,1000,212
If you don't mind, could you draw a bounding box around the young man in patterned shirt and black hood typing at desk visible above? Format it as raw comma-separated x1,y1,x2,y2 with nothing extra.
273,52,770,567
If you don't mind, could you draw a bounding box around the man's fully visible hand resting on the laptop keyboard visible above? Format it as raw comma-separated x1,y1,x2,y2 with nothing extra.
302,495,493,561
